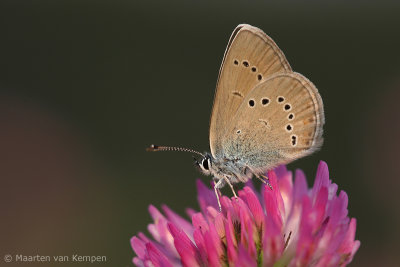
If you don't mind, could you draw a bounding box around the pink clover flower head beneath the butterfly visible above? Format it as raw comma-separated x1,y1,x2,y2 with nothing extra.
131,162,360,267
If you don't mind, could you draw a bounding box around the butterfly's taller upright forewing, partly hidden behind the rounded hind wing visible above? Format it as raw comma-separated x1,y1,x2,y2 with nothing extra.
210,24,291,157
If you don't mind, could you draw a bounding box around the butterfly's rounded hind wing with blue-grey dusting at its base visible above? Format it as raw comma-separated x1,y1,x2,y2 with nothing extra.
222,72,325,172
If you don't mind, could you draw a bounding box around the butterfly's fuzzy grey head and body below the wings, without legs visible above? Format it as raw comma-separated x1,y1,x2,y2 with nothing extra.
197,153,252,187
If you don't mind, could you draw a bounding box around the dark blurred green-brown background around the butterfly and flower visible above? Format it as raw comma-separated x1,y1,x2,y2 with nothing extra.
0,0,400,266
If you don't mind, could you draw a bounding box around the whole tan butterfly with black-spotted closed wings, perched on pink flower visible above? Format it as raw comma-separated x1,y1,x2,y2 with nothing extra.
147,24,325,210
